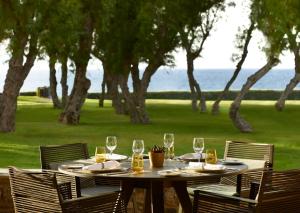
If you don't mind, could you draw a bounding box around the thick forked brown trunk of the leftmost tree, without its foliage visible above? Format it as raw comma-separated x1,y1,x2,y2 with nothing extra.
0,34,37,132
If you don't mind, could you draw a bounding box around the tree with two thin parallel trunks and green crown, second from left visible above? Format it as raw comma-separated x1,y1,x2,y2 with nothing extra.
40,0,82,108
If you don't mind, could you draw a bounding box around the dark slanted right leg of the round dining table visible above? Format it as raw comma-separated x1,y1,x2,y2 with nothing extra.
172,181,193,213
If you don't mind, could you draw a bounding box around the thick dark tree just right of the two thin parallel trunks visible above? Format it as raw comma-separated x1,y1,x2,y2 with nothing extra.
59,0,99,124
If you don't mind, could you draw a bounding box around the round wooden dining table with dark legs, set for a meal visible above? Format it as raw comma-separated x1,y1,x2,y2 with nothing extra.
58,155,261,213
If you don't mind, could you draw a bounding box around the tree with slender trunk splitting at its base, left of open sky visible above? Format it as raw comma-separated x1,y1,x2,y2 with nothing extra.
176,1,224,112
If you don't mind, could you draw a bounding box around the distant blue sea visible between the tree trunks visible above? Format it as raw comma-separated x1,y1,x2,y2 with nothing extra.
0,69,300,92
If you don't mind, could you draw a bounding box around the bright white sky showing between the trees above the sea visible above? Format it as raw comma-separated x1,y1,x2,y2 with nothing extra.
0,1,294,76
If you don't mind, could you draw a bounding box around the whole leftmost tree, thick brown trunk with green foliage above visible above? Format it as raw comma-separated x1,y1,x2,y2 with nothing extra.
0,0,47,132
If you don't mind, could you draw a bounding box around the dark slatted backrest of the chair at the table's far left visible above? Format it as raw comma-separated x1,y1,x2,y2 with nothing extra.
40,143,89,169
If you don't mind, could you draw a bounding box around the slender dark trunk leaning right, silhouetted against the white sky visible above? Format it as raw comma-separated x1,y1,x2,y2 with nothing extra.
212,22,254,115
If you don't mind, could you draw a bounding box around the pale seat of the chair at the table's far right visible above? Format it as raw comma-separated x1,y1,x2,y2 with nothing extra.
187,183,237,196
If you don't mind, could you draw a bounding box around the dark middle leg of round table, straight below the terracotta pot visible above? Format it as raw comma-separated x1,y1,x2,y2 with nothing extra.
151,181,164,213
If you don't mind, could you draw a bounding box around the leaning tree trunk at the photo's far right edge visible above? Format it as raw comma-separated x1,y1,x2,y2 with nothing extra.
275,47,300,111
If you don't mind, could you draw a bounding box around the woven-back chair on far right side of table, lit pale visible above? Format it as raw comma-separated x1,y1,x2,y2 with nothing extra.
188,141,274,196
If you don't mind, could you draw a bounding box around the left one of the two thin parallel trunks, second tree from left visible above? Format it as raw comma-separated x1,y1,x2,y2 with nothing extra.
49,55,62,109
